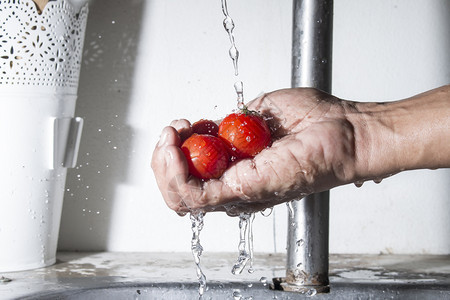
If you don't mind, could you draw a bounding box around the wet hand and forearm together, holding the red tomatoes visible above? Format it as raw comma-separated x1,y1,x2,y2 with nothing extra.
152,85,450,215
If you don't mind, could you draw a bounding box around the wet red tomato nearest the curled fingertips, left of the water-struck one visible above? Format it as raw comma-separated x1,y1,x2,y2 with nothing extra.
181,133,230,180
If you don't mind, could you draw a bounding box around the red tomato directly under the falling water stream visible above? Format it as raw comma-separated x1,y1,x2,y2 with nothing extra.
219,112,271,158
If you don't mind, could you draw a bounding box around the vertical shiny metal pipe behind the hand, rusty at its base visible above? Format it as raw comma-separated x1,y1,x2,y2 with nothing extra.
281,0,333,293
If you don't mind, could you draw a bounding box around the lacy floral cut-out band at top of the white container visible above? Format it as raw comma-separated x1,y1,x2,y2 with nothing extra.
0,0,88,89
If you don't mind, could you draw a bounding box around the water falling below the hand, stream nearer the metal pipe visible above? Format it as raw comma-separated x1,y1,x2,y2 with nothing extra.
231,213,255,275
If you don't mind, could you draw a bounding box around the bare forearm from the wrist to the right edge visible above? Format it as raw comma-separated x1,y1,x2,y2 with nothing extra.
347,85,450,180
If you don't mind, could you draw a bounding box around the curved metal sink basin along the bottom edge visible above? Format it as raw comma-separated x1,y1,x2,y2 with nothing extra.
22,282,450,300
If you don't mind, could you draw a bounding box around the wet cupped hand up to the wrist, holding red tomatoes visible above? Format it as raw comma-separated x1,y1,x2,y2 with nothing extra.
152,88,355,215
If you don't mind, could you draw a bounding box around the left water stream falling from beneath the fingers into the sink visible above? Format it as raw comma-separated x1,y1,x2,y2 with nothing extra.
190,212,206,299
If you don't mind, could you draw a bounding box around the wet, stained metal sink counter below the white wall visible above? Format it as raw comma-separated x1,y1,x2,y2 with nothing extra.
0,252,450,300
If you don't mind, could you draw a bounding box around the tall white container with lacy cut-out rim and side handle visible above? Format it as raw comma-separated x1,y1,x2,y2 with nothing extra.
0,0,88,272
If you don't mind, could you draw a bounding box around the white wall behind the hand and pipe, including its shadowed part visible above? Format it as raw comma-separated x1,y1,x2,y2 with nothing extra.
59,0,450,253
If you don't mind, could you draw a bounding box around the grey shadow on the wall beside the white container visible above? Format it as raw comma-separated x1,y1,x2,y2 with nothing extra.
58,0,145,250
